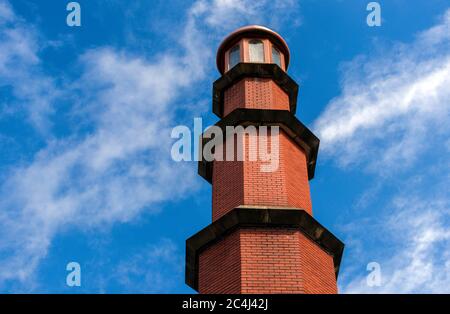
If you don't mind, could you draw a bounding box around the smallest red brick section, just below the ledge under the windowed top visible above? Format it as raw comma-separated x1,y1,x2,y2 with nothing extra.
224,78,289,116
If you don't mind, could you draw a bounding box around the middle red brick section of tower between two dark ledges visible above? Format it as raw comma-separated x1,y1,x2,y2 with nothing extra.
212,129,312,221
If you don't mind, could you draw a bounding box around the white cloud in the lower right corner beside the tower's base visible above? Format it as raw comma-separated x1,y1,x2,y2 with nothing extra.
341,196,450,293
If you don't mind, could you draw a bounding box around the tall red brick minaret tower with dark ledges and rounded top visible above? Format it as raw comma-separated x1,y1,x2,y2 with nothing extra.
186,26,344,293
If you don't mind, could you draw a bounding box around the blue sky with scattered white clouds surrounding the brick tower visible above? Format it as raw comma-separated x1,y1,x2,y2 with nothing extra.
0,0,450,293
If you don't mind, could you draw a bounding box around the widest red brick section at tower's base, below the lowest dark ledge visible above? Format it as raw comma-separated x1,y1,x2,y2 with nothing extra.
199,228,337,293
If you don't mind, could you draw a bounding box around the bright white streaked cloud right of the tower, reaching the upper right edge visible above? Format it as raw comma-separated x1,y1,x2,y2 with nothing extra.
314,11,450,172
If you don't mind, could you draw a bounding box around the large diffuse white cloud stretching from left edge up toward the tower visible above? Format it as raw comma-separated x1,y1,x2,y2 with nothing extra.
0,30,196,288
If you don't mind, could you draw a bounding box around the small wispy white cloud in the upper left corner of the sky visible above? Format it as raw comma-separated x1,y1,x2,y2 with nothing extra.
0,0,60,133
